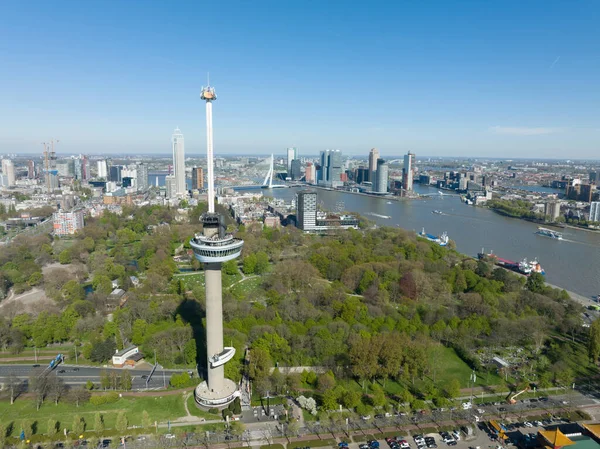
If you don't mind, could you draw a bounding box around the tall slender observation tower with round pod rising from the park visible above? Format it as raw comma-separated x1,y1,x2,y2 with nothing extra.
190,82,244,408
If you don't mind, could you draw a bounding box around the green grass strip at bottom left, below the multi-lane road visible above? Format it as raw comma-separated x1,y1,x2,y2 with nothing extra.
0,395,186,436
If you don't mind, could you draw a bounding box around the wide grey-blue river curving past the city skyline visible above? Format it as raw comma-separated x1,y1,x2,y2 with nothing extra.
263,186,600,298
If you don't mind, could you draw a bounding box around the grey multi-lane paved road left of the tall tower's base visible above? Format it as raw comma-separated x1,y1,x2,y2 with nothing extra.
0,363,188,390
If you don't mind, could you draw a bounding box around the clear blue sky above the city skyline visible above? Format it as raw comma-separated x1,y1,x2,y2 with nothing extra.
0,0,600,158
